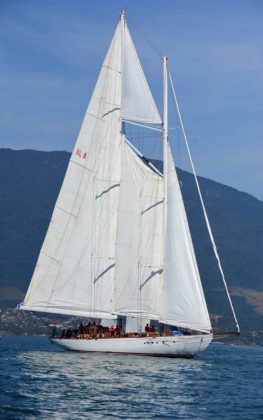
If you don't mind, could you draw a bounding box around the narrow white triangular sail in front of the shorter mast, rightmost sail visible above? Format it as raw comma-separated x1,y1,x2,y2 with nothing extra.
160,145,211,331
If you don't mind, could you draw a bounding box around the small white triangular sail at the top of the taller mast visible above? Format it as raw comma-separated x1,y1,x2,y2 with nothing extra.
121,24,162,124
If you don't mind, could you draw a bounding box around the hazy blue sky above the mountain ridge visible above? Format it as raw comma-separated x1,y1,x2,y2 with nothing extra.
0,0,263,200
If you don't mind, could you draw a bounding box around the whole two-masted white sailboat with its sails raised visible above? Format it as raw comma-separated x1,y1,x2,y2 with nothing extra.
20,12,239,357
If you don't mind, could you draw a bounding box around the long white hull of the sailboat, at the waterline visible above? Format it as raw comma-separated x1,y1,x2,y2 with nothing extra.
52,334,213,358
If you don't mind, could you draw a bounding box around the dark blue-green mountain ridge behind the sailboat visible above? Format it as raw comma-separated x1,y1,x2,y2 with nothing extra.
0,149,263,343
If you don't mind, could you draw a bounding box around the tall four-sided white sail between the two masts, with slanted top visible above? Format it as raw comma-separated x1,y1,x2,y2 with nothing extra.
115,139,163,319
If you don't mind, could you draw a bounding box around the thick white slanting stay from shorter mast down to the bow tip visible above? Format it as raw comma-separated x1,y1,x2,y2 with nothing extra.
169,72,240,332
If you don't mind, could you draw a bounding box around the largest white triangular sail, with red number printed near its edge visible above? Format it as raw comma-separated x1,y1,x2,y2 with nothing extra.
22,17,122,318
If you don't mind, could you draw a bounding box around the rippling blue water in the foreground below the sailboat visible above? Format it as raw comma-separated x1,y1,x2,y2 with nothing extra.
0,337,263,420
